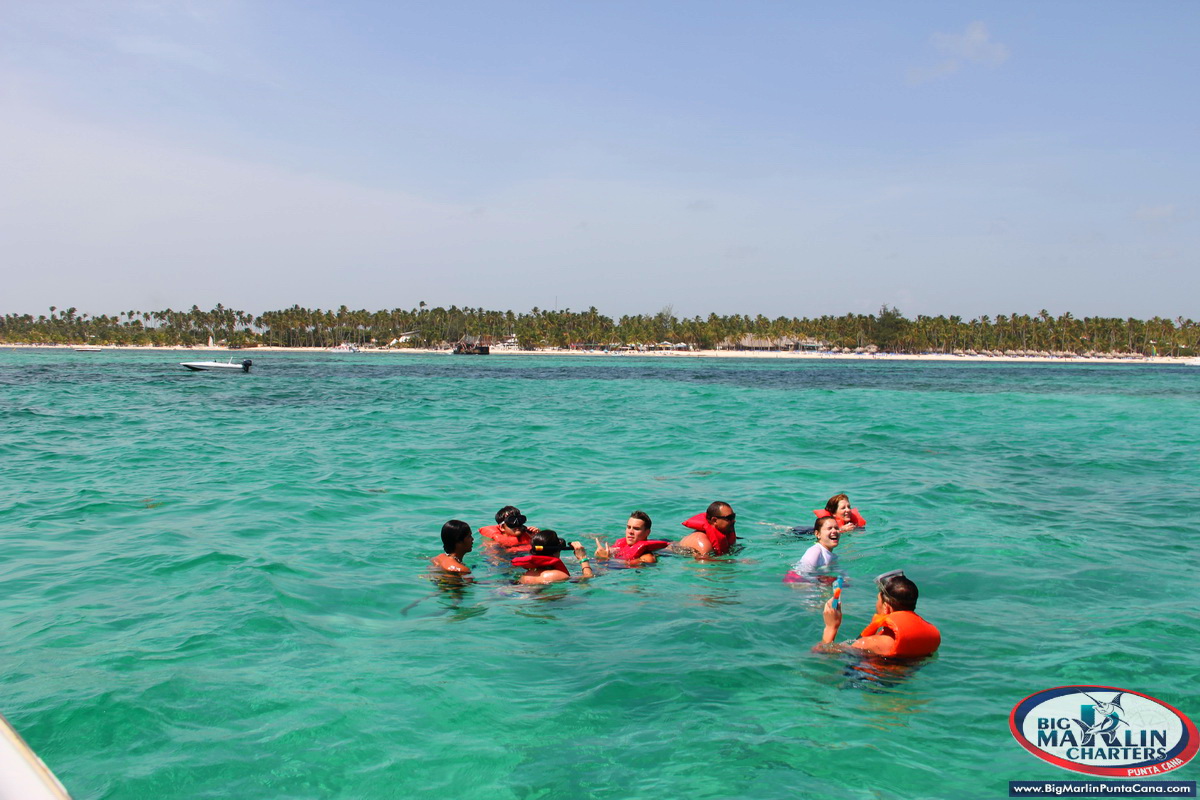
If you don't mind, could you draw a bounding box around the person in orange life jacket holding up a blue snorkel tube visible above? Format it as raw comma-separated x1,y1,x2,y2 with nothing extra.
815,570,942,658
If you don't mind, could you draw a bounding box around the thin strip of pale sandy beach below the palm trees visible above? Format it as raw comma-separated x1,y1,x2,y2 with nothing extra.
0,343,1195,366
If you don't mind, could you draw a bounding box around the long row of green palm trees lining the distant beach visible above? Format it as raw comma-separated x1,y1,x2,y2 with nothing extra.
0,301,1200,356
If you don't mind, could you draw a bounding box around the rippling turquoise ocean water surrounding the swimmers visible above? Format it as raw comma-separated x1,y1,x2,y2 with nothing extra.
0,349,1200,799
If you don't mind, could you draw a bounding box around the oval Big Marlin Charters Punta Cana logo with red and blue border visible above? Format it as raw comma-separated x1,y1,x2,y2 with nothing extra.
1008,686,1200,777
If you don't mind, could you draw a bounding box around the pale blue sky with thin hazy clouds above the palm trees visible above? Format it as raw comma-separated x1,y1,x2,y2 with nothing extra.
0,0,1200,318
